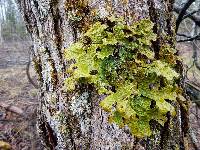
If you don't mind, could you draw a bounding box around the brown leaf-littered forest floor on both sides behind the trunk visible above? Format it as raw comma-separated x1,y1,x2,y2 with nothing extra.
0,42,200,150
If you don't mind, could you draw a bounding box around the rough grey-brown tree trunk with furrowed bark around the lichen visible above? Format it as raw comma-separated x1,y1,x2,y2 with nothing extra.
17,0,187,150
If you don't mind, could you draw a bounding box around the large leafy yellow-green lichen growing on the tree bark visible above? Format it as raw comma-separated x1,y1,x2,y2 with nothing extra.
65,17,179,137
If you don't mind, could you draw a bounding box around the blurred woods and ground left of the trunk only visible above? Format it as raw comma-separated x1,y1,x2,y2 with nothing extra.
0,0,43,150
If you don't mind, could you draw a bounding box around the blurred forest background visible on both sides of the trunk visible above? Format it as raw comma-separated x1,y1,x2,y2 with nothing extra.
0,0,200,150
